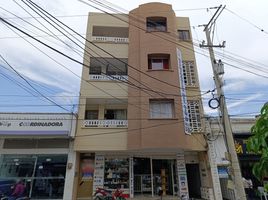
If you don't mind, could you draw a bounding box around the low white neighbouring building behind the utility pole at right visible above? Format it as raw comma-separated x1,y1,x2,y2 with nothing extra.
210,118,261,199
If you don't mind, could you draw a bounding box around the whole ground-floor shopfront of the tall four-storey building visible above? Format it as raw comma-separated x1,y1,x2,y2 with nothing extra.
77,152,207,199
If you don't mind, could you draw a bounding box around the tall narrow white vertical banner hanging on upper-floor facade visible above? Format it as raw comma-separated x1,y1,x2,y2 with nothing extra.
177,48,191,135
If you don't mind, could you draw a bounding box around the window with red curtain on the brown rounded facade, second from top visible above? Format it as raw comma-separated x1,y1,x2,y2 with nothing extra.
148,54,170,70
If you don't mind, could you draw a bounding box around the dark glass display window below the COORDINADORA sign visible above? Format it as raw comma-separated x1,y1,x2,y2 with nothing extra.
0,155,67,199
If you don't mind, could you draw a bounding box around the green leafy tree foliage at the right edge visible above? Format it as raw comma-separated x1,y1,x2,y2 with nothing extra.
247,103,268,181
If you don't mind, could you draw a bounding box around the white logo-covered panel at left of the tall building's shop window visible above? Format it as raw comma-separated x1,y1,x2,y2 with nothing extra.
93,154,105,192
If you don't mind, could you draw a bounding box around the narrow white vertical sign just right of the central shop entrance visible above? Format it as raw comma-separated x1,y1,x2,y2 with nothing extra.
177,153,189,199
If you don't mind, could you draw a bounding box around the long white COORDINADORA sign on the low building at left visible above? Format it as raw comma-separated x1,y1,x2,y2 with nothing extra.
0,113,75,135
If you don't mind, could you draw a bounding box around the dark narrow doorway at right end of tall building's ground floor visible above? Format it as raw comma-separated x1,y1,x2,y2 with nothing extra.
186,164,201,198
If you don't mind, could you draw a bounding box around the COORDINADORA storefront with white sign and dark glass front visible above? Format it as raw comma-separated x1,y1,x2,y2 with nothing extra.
0,113,76,199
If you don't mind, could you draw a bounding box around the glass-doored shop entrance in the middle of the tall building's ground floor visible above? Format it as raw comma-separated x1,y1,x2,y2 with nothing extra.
134,157,176,196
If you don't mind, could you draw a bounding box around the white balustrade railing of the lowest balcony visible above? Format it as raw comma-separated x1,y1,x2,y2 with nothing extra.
84,120,128,128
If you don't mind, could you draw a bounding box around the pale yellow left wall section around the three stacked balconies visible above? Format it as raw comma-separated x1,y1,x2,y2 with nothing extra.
74,13,128,151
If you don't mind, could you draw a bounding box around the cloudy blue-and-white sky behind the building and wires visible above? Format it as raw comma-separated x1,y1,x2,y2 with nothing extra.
0,0,268,117
